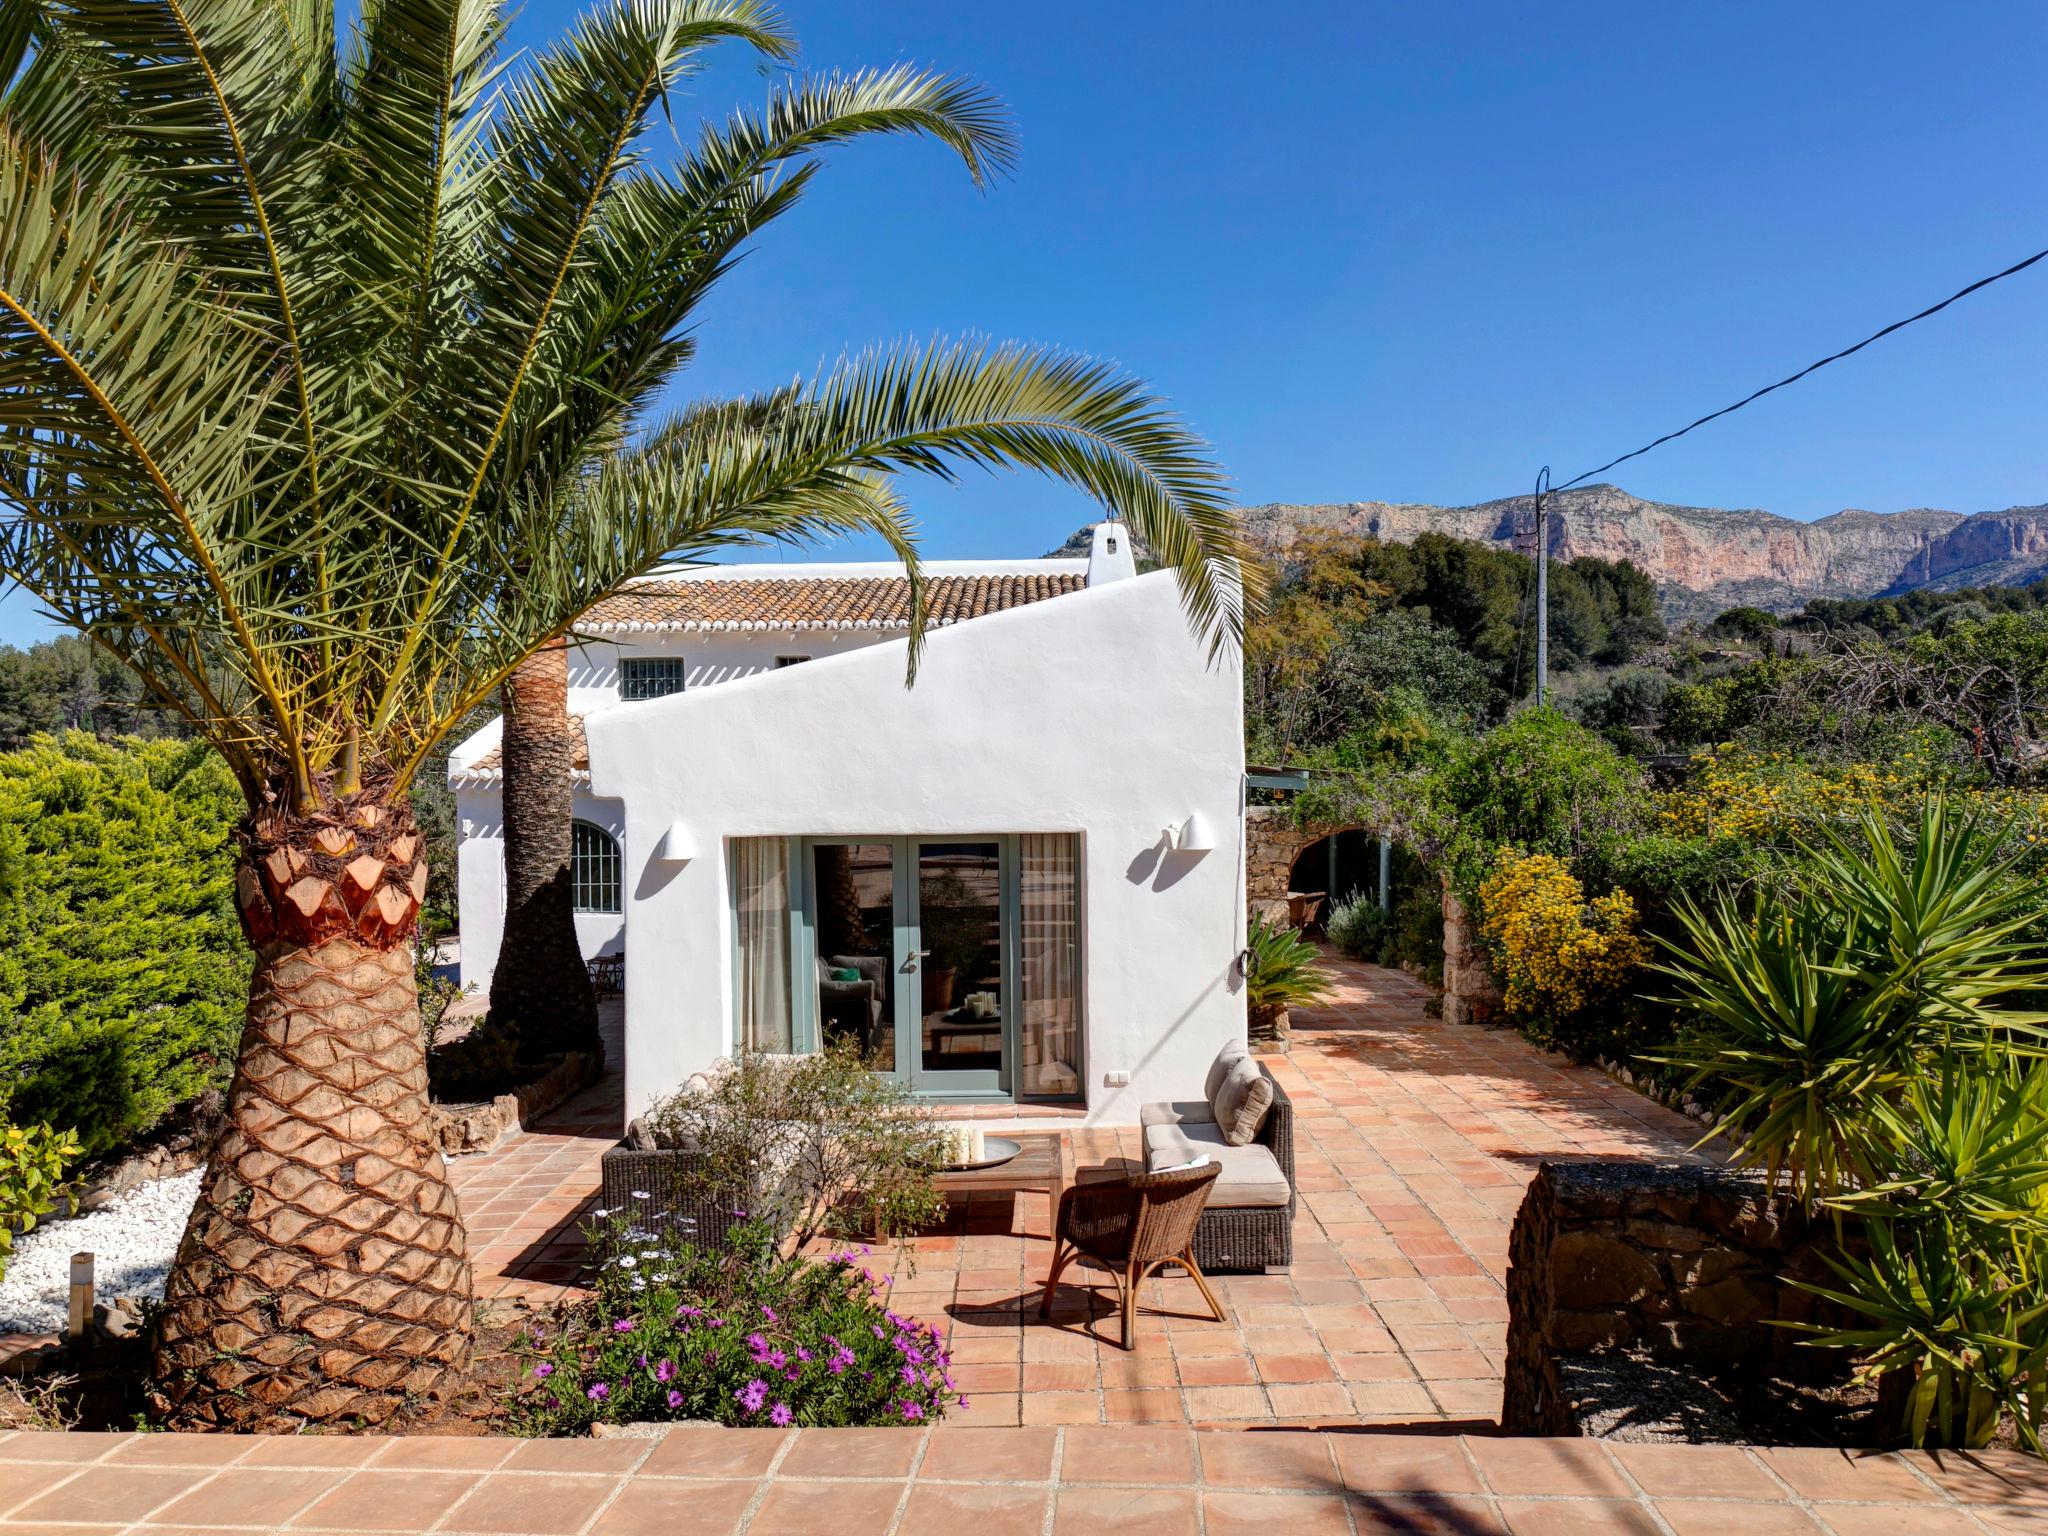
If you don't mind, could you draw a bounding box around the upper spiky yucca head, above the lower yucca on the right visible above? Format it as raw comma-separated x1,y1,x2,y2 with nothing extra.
1655,799,2048,1198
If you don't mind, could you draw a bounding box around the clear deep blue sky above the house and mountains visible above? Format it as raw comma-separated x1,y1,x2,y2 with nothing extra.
0,0,2048,639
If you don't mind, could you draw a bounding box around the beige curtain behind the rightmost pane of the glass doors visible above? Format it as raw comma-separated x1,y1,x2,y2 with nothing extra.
1018,831,1081,1098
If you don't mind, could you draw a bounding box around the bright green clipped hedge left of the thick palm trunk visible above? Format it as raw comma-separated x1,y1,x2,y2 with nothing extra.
0,731,250,1157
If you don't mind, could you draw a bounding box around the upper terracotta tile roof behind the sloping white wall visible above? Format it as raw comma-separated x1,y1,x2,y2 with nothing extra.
575,571,1087,633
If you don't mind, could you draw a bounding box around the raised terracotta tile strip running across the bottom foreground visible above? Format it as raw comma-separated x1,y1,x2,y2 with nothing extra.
0,1425,2048,1536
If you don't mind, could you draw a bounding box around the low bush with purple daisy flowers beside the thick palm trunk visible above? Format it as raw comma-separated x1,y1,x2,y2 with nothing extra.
512,1221,967,1436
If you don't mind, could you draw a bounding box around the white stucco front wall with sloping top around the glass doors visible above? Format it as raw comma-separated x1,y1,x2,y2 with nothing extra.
585,573,1245,1124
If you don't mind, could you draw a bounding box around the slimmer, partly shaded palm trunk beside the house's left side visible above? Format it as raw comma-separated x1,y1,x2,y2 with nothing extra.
492,639,604,1057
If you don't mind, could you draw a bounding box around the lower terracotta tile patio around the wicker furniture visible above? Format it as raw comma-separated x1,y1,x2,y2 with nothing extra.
455,961,1698,1427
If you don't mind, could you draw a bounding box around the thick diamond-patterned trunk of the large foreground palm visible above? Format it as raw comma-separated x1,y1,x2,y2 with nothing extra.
152,788,473,1432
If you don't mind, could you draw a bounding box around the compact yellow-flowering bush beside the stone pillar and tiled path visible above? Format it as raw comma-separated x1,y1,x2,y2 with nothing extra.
1479,848,1649,1022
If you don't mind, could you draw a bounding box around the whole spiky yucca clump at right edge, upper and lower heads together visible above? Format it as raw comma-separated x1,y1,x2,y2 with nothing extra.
1661,797,2048,1452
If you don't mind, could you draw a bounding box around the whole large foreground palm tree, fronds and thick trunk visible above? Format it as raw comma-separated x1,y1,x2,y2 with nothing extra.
0,0,1247,1430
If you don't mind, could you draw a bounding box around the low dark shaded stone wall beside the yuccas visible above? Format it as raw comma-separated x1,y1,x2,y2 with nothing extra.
1501,1163,1829,1436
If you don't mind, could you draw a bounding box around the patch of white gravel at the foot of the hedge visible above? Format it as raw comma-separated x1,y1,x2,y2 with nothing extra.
0,1167,205,1333
